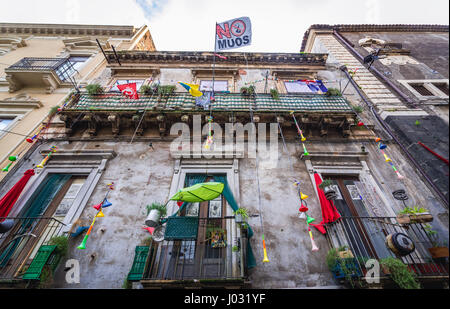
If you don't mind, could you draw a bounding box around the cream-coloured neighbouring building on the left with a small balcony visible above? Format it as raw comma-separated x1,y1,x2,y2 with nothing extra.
0,23,155,179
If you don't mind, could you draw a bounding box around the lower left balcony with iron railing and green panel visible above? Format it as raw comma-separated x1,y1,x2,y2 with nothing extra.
0,217,65,287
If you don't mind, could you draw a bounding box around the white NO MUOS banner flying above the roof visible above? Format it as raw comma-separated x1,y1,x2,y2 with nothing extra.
216,17,252,51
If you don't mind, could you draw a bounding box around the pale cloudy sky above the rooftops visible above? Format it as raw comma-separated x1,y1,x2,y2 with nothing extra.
0,0,449,53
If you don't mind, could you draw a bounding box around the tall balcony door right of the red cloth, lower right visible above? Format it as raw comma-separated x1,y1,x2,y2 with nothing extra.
324,176,391,258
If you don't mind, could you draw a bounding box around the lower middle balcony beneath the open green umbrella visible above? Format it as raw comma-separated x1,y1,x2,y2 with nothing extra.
140,216,247,288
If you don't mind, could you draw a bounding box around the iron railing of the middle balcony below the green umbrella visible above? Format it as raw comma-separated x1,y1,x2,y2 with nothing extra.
143,218,247,281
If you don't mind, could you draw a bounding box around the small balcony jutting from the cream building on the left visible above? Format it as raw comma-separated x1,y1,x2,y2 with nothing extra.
5,57,75,93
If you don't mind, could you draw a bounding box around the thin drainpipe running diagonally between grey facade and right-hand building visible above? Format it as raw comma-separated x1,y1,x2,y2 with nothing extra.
340,65,448,208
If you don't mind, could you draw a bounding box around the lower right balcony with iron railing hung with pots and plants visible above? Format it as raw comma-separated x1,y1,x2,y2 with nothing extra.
326,217,449,284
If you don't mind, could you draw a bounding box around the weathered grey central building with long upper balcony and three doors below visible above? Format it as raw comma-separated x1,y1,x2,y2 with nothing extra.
0,22,448,288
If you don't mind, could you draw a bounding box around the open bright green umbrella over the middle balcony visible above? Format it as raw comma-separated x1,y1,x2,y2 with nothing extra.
170,182,225,203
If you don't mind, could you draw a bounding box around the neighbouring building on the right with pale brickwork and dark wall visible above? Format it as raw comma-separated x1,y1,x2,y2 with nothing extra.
301,25,449,207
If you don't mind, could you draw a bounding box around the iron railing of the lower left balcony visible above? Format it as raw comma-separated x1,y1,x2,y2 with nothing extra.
0,217,65,279
